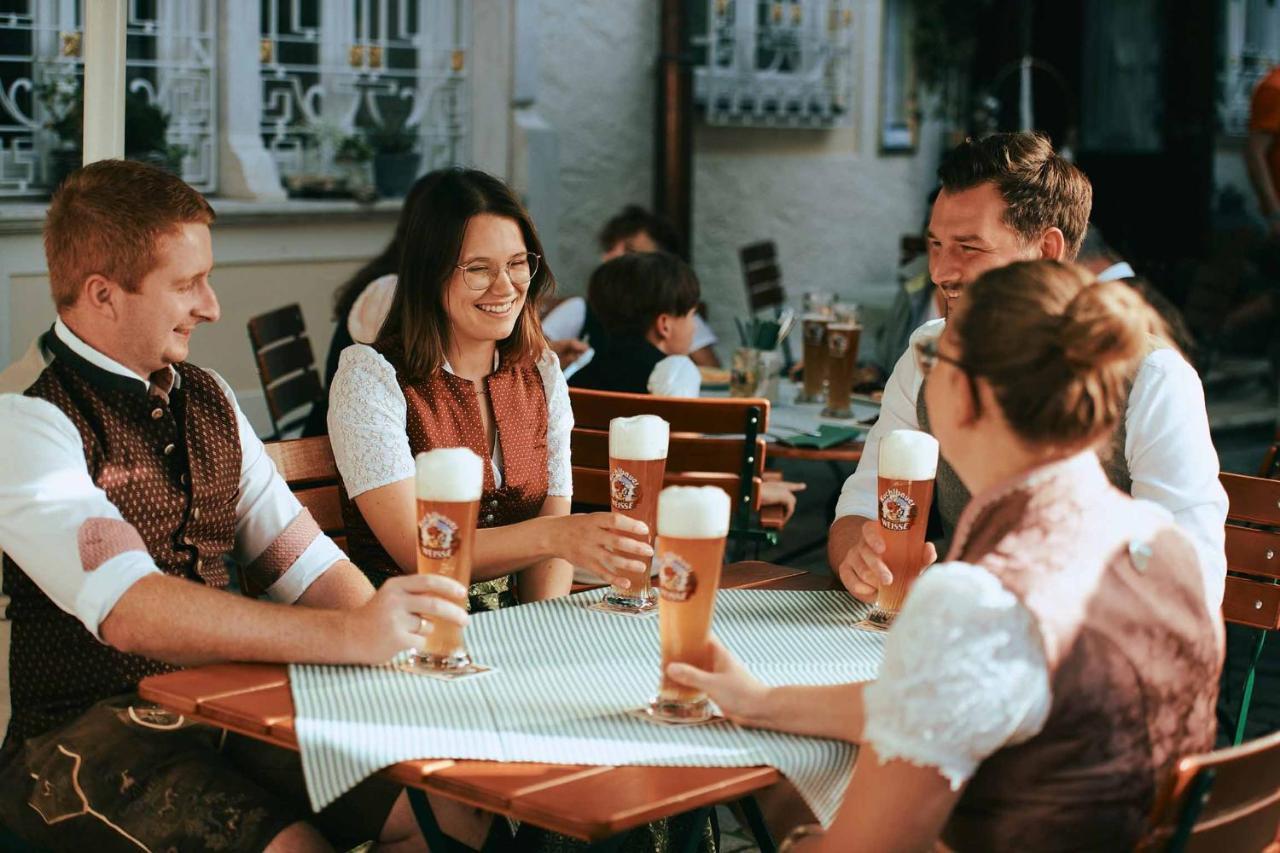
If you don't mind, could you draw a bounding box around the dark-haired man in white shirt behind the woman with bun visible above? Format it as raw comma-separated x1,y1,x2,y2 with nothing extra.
827,133,1226,612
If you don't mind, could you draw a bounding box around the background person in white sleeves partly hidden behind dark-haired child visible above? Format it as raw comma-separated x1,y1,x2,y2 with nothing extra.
543,205,719,368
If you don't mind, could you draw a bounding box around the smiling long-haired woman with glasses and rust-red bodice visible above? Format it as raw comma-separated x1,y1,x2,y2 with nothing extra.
329,169,649,611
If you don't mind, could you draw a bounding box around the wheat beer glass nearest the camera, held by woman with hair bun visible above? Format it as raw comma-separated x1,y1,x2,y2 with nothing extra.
649,485,728,722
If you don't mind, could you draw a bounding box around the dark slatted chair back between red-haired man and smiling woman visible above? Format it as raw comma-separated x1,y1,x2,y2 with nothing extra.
248,302,324,439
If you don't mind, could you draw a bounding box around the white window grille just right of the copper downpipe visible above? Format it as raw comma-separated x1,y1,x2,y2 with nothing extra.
690,0,855,128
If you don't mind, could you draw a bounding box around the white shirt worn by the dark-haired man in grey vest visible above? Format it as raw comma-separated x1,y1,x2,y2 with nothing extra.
836,320,1226,612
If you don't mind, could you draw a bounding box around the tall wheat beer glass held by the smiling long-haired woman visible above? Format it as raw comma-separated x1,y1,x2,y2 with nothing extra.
604,415,671,611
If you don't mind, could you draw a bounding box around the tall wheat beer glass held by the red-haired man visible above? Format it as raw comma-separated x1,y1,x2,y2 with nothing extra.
406,447,484,672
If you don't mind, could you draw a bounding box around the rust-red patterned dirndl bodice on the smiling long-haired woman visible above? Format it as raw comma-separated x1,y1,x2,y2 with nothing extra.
343,341,548,612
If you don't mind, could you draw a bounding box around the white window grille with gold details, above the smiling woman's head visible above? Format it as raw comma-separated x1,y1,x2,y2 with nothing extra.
259,0,470,182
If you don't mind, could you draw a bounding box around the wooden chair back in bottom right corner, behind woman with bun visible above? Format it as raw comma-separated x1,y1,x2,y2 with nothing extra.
1138,733,1280,853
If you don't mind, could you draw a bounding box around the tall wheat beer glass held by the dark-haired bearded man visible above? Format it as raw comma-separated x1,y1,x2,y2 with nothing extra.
867,429,938,628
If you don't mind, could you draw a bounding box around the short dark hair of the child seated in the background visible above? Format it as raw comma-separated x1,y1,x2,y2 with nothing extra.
586,252,701,336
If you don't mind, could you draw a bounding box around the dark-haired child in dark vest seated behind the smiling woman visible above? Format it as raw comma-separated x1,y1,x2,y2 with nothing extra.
568,251,805,521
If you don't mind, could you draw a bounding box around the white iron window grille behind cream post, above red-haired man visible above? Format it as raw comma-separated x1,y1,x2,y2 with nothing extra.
0,0,218,197
